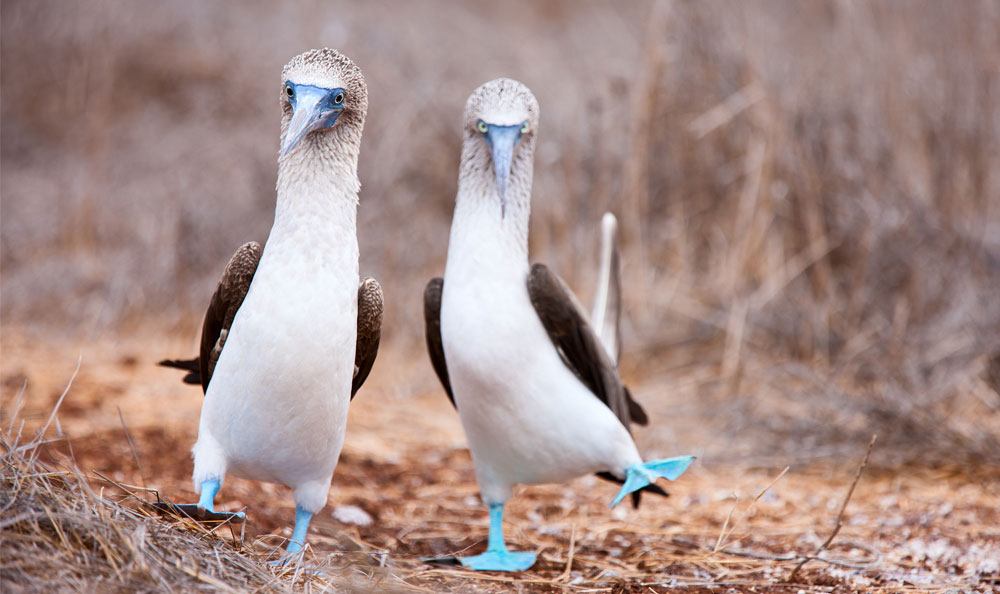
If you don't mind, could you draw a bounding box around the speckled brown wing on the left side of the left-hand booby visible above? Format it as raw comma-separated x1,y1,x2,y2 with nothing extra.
199,241,263,392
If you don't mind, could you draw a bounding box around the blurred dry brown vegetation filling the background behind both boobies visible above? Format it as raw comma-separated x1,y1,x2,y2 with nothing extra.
0,0,1000,462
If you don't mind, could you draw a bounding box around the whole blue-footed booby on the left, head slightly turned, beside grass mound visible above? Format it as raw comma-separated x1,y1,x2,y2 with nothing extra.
163,49,382,554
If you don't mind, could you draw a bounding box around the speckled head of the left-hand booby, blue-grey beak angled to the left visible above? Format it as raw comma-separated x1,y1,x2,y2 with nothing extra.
281,48,368,156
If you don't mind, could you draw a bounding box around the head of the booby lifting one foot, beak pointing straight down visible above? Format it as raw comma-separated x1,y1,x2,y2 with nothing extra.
463,78,538,217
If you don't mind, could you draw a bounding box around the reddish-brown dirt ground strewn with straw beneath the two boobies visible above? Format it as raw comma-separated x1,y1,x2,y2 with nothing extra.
2,332,1000,592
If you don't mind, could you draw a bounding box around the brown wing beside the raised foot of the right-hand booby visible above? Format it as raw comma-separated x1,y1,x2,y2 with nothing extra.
528,264,648,429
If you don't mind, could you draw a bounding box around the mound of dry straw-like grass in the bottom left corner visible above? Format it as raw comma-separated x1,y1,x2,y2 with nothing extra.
0,376,414,592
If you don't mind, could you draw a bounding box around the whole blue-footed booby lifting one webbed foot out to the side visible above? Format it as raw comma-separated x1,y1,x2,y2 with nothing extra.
424,79,692,571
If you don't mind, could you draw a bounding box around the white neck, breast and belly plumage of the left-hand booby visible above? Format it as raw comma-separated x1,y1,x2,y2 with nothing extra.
193,147,359,513
